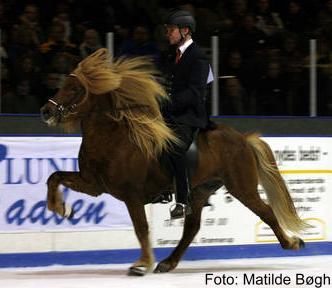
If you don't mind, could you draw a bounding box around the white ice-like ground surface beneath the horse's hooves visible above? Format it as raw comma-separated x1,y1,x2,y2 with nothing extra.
0,256,332,288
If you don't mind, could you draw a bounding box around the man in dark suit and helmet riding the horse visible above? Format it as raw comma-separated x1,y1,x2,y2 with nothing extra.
162,9,209,219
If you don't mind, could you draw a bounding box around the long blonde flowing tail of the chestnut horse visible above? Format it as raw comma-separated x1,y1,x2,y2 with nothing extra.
246,134,310,233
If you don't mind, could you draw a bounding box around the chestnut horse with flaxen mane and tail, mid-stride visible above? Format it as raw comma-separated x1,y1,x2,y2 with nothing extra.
41,49,307,275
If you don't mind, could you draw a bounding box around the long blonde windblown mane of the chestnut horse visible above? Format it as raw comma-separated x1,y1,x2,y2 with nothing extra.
74,48,180,157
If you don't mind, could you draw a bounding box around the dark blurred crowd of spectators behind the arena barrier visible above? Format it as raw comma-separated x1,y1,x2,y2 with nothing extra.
0,0,332,116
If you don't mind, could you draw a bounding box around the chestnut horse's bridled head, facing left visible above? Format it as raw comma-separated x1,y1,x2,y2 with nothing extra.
40,74,87,126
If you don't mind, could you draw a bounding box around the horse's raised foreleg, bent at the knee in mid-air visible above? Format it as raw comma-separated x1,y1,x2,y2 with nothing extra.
47,171,99,217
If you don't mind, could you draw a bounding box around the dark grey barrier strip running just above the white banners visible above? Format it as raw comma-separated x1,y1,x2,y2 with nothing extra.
0,114,332,135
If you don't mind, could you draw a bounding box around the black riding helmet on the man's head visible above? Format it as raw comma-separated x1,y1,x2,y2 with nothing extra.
164,9,196,32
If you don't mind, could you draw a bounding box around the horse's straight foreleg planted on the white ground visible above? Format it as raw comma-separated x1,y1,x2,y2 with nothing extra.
125,200,154,276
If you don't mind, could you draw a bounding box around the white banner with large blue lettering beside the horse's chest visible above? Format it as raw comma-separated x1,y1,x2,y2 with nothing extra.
0,137,132,233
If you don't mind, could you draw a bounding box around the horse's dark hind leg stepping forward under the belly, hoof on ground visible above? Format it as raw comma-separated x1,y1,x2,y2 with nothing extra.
154,189,212,273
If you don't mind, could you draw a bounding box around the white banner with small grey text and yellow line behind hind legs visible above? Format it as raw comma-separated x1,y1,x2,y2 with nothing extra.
152,137,332,247
